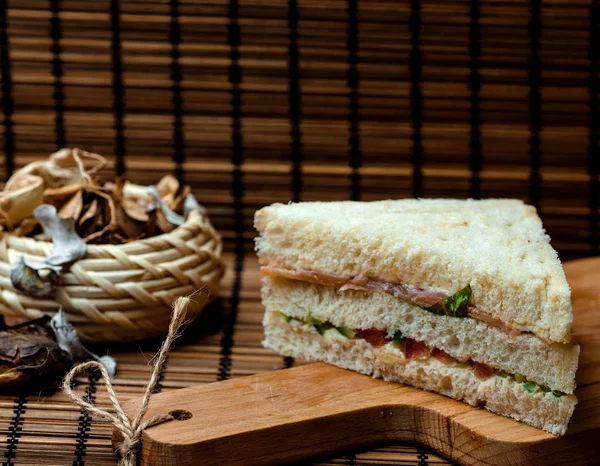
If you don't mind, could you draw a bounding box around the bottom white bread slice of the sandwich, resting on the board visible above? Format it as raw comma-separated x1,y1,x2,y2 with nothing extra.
263,311,577,435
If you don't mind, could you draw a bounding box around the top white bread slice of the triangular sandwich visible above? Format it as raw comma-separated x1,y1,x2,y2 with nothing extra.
255,199,573,343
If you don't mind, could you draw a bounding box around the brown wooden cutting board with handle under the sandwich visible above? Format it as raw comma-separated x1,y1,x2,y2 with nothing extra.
117,258,600,466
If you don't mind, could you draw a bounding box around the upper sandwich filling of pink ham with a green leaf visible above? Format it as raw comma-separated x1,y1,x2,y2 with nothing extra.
260,265,552,344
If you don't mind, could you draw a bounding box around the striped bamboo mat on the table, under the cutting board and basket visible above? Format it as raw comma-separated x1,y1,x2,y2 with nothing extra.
0,255,450,466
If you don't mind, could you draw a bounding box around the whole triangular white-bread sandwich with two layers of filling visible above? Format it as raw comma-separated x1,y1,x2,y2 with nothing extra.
255,199,579,435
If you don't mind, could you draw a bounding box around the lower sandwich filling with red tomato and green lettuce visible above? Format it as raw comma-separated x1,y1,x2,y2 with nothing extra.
279,313,565,398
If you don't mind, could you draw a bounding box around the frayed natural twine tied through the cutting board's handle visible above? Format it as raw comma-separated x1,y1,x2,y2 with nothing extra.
62,297,190,466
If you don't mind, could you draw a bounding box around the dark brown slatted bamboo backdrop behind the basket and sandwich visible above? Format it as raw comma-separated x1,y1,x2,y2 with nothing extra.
0,0,600,259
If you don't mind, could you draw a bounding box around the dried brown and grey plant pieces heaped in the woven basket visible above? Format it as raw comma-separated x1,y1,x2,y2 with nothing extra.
0,149,203,297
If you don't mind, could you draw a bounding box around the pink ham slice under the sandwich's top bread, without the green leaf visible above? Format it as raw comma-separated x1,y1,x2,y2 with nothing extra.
260,265,532,338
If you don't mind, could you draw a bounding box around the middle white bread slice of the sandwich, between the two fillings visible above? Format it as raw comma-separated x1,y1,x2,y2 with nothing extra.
261,277,579,393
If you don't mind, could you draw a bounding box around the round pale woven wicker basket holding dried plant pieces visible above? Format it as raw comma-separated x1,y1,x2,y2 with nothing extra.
0,211,225,342
